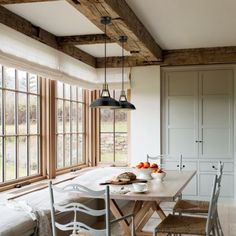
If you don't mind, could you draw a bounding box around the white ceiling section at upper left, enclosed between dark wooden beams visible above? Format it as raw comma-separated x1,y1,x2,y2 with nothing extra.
5,1,103,36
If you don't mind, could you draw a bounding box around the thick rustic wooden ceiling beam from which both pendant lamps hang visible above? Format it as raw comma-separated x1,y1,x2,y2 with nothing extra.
67,0,162,61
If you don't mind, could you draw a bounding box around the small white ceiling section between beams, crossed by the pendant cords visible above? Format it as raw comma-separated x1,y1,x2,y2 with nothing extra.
76,43,131,57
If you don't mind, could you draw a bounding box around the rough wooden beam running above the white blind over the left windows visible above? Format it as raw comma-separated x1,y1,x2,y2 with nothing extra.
0,6,96,67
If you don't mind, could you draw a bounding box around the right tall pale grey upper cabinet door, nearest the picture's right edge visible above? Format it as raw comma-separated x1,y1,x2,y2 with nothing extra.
199,70,233,160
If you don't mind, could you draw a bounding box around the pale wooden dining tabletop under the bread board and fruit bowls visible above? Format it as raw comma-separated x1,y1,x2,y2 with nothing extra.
73,167,196,201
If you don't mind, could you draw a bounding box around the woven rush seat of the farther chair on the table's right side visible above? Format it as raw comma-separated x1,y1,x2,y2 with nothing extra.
173,199,209,214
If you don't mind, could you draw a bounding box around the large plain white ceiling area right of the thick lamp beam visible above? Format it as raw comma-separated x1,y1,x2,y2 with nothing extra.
126,0,236,49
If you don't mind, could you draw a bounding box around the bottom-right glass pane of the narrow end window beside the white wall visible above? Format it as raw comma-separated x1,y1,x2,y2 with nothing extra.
115,134,128,162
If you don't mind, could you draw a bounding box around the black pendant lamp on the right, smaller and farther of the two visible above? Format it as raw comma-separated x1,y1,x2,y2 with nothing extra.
117,36,136,110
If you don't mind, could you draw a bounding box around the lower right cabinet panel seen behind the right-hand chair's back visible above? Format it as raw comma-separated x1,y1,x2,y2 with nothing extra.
199,174,234,197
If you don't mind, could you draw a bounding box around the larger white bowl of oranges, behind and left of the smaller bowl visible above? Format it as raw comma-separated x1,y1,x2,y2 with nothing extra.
135,161,158,180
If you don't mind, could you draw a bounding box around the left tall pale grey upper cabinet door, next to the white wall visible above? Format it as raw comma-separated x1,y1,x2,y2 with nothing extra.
165,71,198,158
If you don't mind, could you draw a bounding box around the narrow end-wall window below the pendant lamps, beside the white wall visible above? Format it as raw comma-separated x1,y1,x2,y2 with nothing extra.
100,91,128,163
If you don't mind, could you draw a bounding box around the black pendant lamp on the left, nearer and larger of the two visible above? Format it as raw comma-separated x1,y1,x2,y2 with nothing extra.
90,16,120,108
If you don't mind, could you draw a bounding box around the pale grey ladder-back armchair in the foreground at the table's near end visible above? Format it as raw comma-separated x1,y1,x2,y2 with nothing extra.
49,181,135,236
